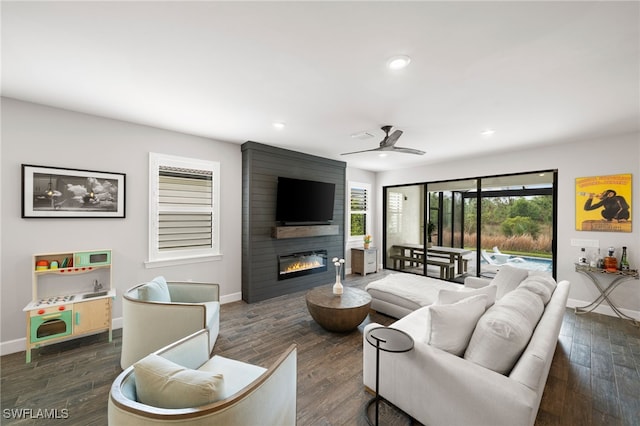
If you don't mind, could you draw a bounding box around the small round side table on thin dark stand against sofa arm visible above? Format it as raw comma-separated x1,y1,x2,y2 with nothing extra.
364,327,413,426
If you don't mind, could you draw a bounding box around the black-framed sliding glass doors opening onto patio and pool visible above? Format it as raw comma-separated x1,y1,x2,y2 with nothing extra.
384,170,556,282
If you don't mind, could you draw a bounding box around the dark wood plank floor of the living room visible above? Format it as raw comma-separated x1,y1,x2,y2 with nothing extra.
0,272,640,426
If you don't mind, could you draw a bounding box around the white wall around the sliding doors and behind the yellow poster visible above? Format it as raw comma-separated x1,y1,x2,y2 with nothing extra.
376,133,640,318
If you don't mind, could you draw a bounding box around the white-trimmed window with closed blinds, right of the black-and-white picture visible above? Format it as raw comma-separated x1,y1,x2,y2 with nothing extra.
149,154,219,261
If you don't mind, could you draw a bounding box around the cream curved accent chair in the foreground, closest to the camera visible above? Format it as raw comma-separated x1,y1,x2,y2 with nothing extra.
108,330,297,426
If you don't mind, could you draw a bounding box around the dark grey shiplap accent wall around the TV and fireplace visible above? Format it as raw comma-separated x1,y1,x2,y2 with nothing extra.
242,142,346,303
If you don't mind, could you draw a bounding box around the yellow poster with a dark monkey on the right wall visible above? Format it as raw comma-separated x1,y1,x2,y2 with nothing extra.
576,173,631,232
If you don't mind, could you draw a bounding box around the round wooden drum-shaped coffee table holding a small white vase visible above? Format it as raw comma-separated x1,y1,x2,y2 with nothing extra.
306,285,371,332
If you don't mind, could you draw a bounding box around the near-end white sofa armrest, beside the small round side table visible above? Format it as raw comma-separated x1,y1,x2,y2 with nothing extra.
363,324,537,426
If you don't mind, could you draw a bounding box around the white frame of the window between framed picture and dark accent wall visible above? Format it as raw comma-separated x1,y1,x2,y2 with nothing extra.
145,152,222,268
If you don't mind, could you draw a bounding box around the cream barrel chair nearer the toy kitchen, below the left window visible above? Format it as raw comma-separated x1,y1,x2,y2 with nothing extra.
120,277,220,370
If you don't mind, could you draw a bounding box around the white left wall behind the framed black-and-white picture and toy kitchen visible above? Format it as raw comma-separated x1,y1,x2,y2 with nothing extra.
0,98,242,354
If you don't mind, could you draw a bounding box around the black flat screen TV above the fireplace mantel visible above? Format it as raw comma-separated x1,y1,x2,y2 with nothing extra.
276,177,336,224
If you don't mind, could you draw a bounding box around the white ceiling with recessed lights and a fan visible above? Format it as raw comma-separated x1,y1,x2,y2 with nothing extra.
1,0,640,171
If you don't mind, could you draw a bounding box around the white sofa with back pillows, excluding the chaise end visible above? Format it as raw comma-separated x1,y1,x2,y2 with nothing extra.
363,268,570,426
